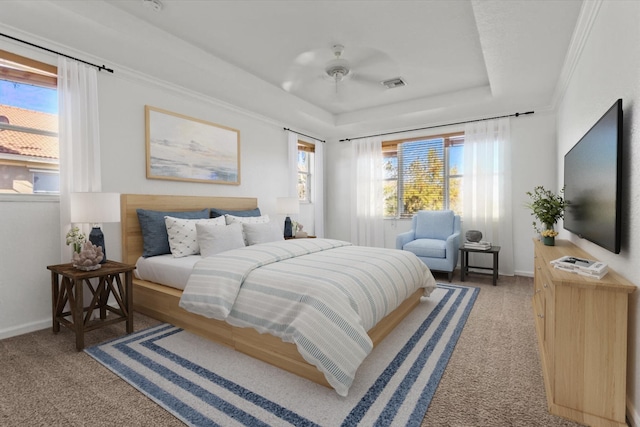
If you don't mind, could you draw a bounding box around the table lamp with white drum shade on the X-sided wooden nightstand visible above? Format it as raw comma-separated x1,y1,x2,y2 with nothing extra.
70,193,120,264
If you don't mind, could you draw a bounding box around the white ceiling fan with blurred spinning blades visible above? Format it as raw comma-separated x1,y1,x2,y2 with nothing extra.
282,44,397,98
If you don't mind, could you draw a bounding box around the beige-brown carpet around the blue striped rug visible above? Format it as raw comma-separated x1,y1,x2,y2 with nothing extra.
0,274,578,426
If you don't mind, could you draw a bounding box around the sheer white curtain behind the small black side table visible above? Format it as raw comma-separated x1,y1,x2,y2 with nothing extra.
462,118,514,275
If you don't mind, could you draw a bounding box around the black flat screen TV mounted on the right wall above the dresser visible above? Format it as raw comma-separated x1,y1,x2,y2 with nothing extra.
564,99,622,254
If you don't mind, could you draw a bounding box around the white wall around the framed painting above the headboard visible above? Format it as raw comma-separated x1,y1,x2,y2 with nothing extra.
99,72,296,262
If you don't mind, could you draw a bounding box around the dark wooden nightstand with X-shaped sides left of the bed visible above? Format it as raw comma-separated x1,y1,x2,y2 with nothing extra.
47,261,136,351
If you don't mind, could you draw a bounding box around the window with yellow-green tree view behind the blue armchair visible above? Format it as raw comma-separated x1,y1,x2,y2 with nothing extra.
382,133,464,218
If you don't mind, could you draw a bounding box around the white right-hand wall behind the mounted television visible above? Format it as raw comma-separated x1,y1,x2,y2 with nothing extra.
557,1,640,426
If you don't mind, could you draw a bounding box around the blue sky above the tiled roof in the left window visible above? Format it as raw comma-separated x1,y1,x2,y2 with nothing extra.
0,80,58,114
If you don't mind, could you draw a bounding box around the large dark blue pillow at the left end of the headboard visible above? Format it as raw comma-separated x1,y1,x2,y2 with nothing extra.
136,209,209,258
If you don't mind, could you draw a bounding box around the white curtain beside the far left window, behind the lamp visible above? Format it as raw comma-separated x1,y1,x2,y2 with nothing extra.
58,57,102,263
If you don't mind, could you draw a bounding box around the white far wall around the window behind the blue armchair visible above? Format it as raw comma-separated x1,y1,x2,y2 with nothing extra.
325,112,557,275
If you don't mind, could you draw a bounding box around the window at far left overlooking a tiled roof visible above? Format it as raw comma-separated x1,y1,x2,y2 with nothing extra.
0,50,60,194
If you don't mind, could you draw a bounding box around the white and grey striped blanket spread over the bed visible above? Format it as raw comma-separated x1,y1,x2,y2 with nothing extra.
180,239,436,396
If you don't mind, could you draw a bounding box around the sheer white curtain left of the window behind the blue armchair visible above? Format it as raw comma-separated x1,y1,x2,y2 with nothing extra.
349,137,384,247
